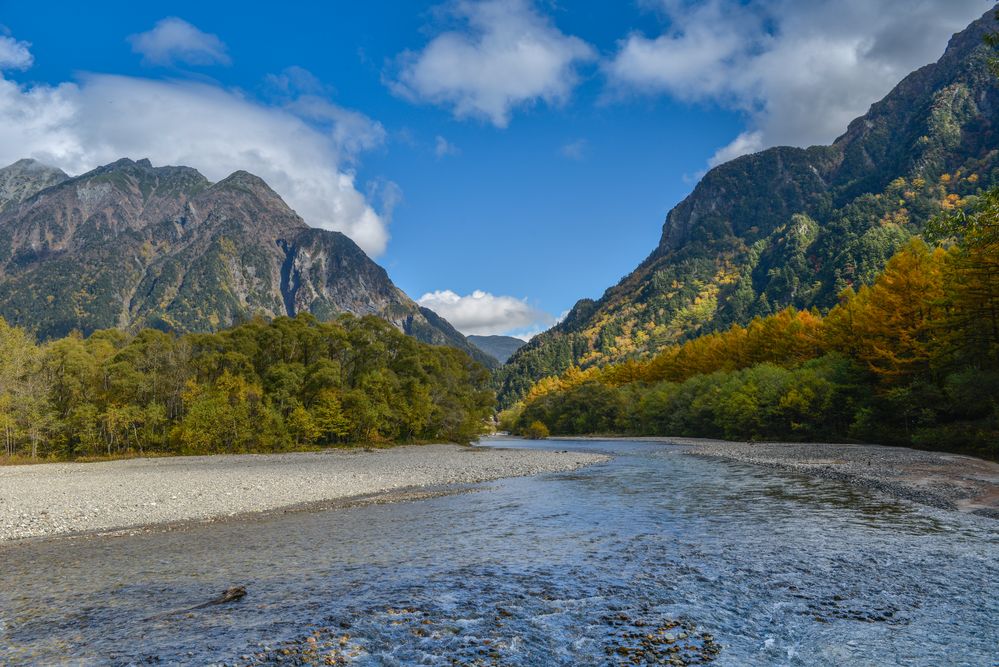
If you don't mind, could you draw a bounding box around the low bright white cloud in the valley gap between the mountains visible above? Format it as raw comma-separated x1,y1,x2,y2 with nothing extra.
417,290,555,340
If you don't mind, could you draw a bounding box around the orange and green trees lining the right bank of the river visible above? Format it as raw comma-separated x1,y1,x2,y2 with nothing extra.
500,190,999,459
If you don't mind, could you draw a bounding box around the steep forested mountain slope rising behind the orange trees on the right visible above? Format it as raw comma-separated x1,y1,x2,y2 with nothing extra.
497,10,999,405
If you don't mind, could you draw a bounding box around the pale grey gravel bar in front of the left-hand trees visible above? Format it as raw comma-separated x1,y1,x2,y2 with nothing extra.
0,445,607,542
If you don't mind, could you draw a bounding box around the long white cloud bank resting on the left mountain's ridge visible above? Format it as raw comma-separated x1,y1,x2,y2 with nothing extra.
0,41,398,255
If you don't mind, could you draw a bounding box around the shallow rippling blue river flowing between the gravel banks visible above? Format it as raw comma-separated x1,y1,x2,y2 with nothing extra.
0,440,999,666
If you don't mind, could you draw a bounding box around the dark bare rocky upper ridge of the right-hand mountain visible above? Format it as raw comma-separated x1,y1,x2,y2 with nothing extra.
650,9,999,260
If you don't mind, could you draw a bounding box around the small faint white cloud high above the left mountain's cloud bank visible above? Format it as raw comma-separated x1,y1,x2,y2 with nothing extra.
128,16,231,65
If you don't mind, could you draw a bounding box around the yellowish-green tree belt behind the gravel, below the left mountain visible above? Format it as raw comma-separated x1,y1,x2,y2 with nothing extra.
0,315,493,460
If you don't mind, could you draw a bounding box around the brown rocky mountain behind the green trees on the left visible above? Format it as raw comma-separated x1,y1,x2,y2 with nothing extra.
0,159,495,366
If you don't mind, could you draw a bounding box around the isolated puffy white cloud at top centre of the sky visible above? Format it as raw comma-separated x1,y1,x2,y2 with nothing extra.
390,0,596,127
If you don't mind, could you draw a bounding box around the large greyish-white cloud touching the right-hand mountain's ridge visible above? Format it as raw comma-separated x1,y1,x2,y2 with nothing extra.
605,0,992,165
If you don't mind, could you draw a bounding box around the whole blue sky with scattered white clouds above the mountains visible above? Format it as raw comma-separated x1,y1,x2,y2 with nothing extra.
0,0,992,335
